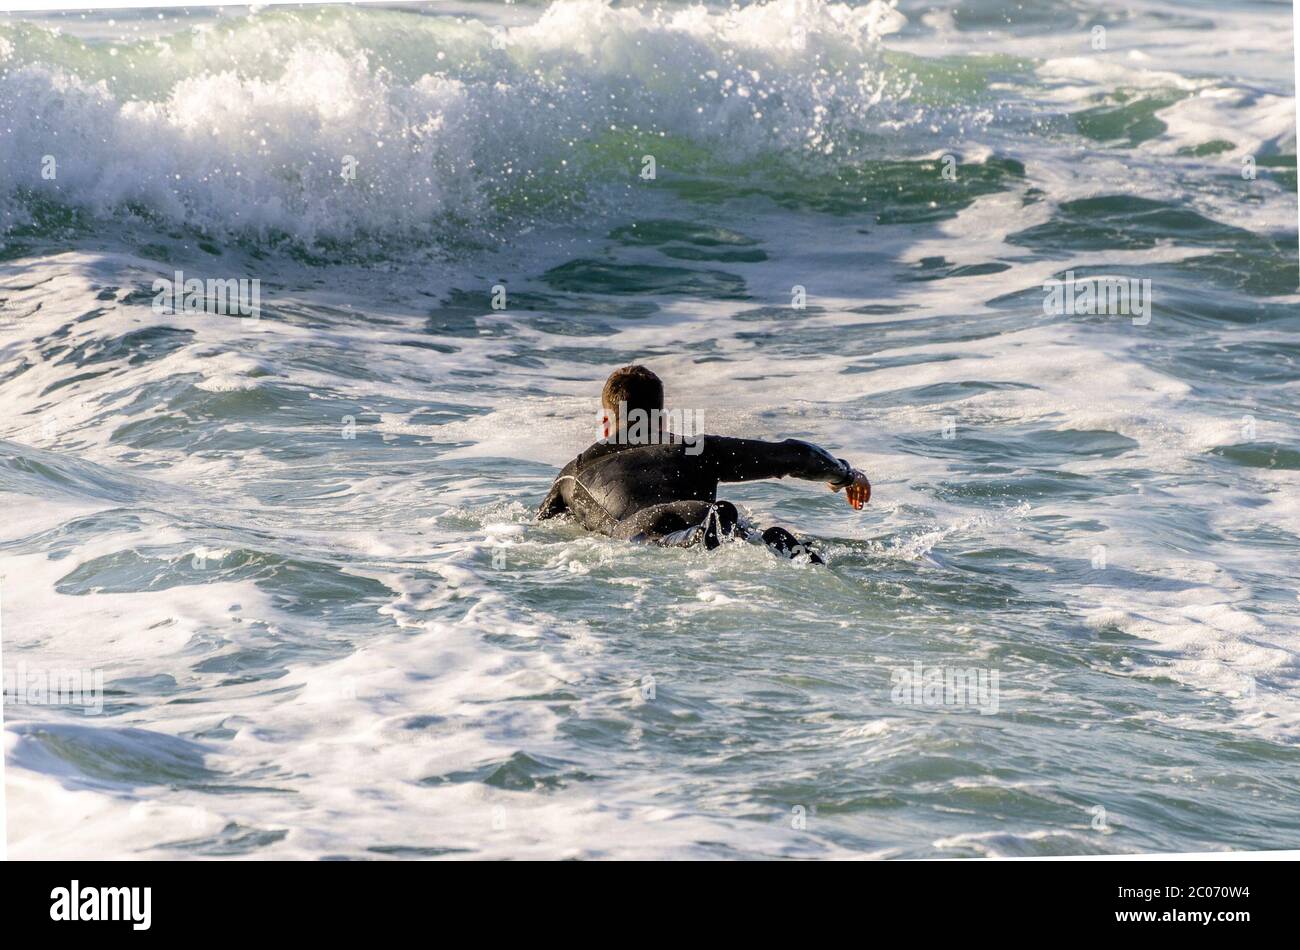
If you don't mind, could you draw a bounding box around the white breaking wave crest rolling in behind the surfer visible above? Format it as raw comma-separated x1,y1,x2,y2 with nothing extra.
0,0,905,244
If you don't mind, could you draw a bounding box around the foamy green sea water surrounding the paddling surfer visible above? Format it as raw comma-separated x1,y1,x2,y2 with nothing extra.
0,0,1300,859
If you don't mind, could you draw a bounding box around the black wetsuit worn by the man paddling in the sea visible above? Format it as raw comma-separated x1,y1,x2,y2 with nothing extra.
537,435,854,560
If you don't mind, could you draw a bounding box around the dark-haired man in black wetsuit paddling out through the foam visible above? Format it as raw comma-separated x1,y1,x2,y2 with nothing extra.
537,366,871,564
